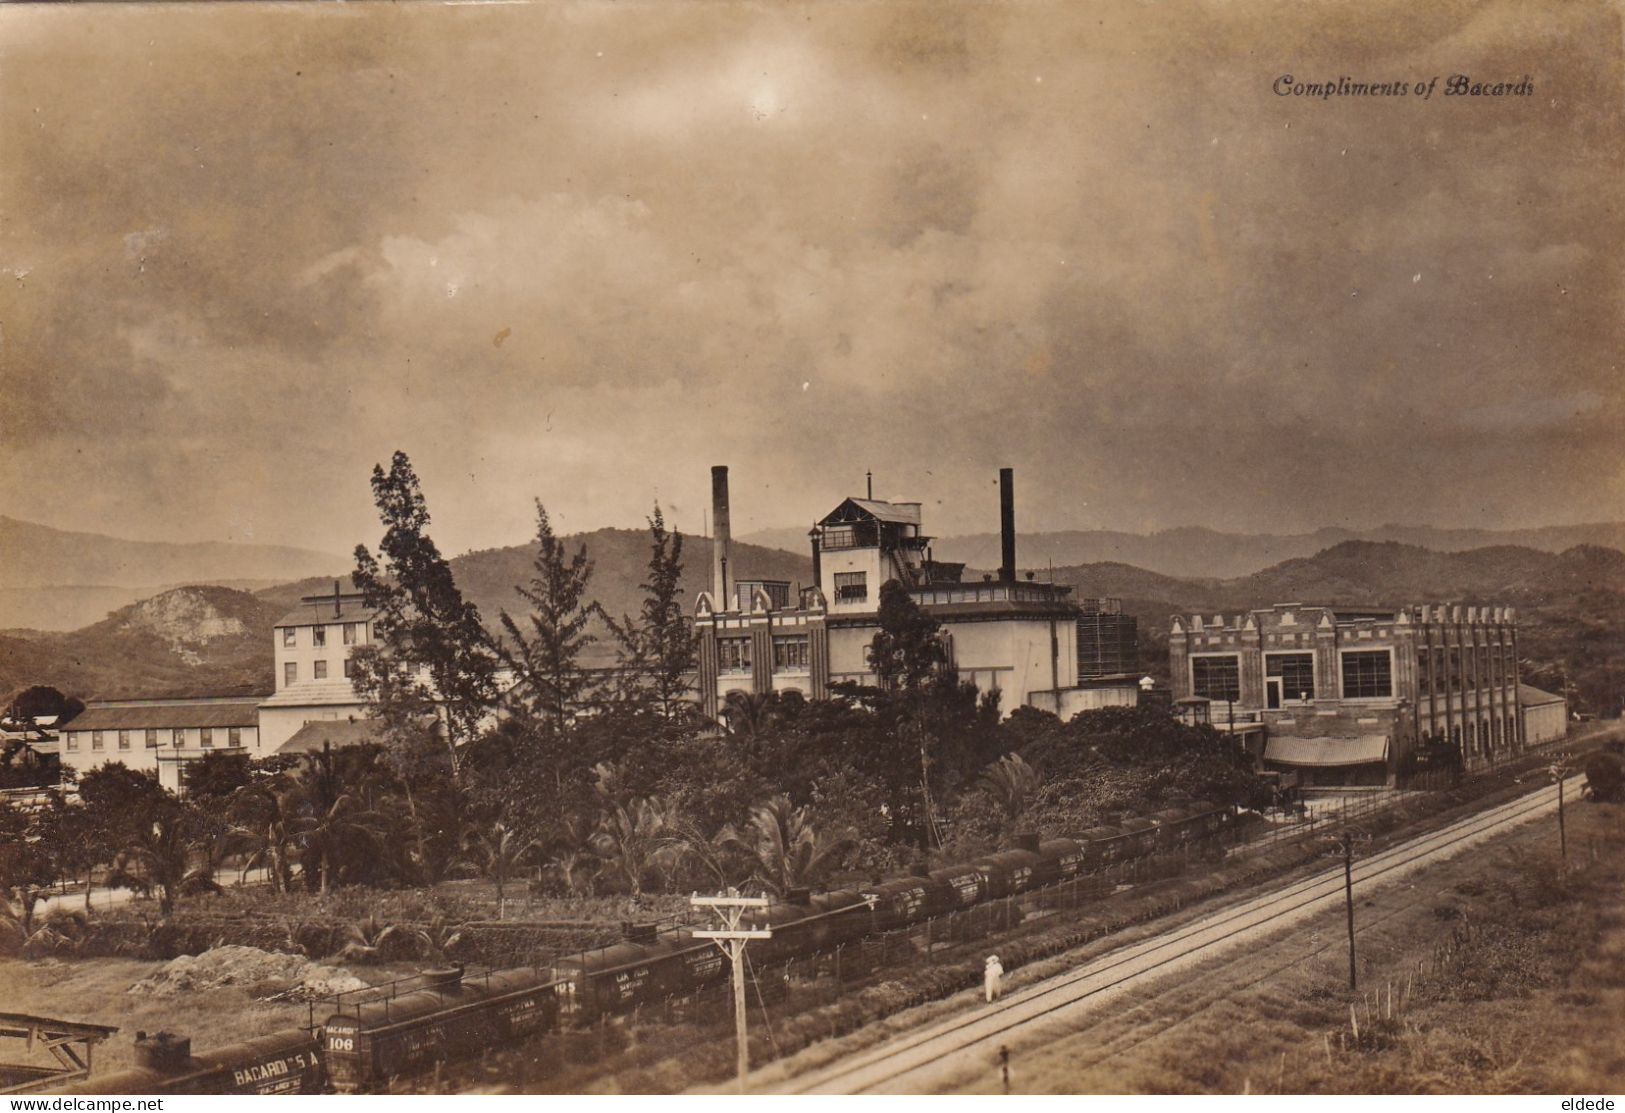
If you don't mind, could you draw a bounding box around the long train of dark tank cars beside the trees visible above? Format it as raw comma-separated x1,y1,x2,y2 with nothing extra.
57,803,1235,1094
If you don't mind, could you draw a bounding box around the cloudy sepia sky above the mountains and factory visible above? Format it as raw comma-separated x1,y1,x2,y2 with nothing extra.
0,0,1625,552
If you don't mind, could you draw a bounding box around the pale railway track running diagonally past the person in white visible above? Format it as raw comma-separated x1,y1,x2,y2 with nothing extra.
767,778,1578,1094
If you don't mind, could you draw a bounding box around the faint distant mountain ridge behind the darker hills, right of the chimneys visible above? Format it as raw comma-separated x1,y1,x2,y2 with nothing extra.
763,522,1625,578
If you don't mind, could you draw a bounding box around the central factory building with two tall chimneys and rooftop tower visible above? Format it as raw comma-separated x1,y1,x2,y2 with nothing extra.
696,466,1138,717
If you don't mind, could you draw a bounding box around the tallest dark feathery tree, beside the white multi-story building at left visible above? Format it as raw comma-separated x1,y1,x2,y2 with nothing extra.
351,452,497,783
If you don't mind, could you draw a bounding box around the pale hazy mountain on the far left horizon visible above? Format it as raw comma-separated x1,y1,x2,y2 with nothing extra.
0,517,349,630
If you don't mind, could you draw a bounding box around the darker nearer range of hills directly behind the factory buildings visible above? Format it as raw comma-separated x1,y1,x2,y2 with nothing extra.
9,530,1625,700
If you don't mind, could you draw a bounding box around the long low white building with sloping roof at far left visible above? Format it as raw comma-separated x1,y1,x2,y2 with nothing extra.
60,695,263,793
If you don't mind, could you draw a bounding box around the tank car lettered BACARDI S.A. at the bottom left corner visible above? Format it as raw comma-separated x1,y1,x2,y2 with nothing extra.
52,1029,327,1094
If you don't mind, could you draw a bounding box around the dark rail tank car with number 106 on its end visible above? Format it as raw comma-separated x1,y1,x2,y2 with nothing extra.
323,967,559,1094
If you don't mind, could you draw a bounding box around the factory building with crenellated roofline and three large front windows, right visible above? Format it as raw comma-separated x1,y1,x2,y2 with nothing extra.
1168,603,1524,785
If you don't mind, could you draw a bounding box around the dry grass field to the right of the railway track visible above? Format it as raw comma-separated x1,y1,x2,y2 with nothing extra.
949,792,1625,1094
